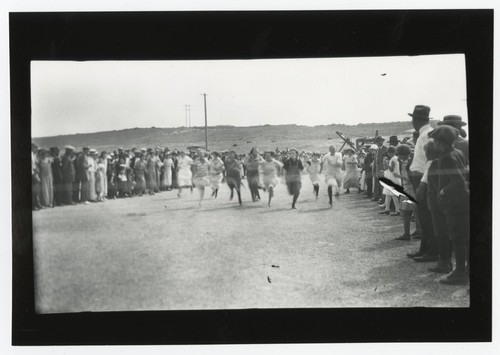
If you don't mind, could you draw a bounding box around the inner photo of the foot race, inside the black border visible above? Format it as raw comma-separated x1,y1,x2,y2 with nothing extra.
31,54,469,313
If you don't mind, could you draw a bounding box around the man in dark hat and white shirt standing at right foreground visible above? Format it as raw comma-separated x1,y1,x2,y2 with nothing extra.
408,105,438,262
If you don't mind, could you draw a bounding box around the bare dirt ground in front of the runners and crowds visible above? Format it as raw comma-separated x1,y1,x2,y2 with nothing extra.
33,176,469,313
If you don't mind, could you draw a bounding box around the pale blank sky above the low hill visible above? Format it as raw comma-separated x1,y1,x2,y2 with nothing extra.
31,54,467,137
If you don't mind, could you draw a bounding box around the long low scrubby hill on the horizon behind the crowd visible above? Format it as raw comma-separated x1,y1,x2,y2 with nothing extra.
32,120,437,153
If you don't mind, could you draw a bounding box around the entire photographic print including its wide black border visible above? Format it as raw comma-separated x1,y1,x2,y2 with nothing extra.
10,5,493,345
